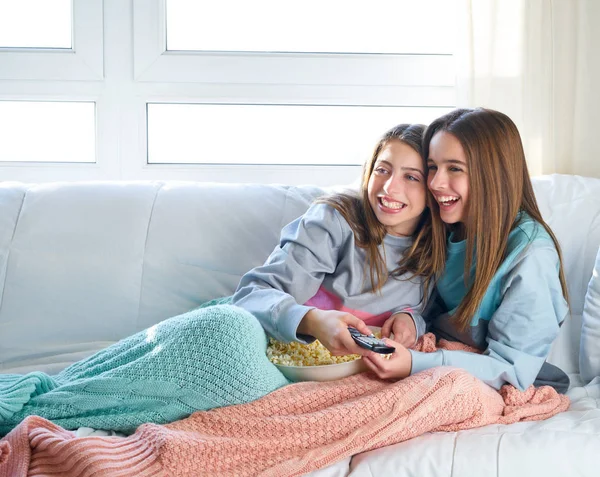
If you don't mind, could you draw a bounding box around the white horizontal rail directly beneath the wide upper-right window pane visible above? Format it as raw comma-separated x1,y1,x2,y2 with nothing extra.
136,52,455,86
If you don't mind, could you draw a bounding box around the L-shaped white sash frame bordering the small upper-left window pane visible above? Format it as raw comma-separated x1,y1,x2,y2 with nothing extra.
0,0,104,80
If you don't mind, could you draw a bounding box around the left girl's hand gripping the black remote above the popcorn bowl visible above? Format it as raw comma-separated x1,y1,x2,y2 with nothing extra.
297,308,371,356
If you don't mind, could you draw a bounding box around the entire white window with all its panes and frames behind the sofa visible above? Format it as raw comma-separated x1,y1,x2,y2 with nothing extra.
0,0,456,186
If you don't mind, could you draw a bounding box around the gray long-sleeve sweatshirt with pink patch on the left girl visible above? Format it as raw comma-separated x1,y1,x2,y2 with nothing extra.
233,204,425,342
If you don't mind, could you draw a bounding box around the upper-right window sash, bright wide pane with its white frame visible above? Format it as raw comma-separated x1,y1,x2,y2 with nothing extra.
134,0,454,87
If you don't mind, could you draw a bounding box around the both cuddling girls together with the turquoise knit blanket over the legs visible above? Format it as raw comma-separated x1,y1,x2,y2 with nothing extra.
0,109,568,435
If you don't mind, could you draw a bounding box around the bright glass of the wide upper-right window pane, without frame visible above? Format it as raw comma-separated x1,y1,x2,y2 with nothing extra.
166,0,455,54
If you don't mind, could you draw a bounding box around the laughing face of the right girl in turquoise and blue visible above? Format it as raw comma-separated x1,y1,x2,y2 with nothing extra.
427,131,469,225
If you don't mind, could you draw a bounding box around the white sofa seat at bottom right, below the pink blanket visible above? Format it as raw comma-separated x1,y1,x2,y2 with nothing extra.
349,382,600,477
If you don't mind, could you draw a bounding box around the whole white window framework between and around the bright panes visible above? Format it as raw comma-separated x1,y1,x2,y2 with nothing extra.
0,0,456,185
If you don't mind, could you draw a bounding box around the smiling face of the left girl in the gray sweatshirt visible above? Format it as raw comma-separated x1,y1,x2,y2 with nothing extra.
367,140,427,236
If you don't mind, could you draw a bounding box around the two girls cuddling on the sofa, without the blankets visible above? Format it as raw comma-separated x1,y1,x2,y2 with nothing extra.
233,109,569,392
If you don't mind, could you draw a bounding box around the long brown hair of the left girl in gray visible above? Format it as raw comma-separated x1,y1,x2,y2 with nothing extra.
319,124,445,297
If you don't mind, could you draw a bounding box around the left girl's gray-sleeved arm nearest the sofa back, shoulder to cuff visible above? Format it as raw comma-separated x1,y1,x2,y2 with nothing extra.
233,204,352,341
